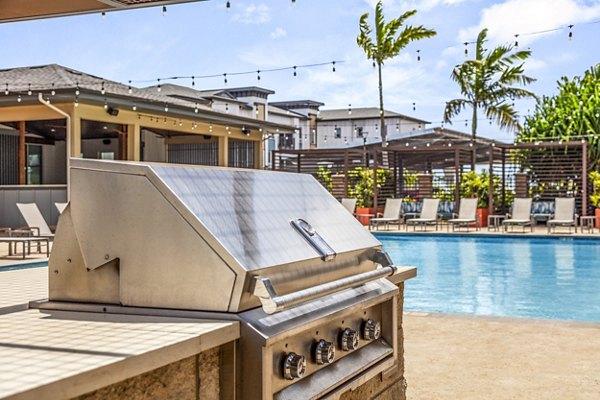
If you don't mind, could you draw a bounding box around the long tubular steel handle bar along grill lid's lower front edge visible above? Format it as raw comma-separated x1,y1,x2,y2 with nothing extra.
254,265,405,314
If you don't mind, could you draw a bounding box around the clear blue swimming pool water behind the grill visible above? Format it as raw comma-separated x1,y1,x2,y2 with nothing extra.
376,234,600,322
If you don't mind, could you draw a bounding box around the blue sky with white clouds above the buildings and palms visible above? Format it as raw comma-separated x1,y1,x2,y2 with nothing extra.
0,0,600,141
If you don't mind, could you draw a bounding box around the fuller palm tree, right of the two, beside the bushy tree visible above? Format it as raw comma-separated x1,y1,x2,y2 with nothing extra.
444,29,536,168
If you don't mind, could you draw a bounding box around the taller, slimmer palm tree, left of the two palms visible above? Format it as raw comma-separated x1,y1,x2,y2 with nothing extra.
356,0,436,146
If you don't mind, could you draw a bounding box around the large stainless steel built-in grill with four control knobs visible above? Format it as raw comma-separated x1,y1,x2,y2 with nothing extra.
44,160,415,399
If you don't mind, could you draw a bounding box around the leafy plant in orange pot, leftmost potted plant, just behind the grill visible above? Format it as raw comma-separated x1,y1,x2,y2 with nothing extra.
348,167,390,225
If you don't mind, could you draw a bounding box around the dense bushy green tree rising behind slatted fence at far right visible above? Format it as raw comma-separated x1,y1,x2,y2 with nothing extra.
517,64,600,170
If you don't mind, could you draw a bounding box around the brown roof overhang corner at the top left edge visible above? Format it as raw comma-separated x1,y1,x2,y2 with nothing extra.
0,0,209,23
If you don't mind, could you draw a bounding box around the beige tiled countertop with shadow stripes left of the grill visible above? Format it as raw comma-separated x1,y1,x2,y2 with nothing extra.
0,309,240,399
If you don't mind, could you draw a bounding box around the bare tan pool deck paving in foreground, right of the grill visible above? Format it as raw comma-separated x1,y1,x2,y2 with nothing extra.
404,313,600,400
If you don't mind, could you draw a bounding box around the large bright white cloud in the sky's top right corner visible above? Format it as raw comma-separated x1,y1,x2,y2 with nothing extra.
459,0,600,46
